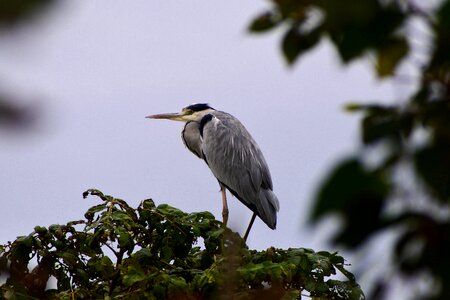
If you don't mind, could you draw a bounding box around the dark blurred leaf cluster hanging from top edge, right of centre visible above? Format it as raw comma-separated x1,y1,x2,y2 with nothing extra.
250,0,409,76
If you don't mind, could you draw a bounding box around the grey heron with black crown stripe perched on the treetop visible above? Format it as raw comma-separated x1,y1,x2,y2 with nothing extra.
147,103,279,240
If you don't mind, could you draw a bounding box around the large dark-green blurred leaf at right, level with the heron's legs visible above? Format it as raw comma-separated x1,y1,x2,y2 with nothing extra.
311,158,389,247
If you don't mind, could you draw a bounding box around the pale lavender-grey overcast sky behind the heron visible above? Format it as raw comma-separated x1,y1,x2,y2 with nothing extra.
0,0,398,290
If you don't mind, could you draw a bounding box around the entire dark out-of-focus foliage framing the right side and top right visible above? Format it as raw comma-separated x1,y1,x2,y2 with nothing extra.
249,0,450,299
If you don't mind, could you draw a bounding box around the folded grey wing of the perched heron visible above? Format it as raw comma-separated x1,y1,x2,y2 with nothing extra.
200,111,279,229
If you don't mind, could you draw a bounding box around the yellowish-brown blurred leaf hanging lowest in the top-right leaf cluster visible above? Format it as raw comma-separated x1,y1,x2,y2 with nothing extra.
376,37,409,77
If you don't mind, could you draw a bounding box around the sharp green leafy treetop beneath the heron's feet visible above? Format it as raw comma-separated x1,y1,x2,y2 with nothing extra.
0,190,364,299
